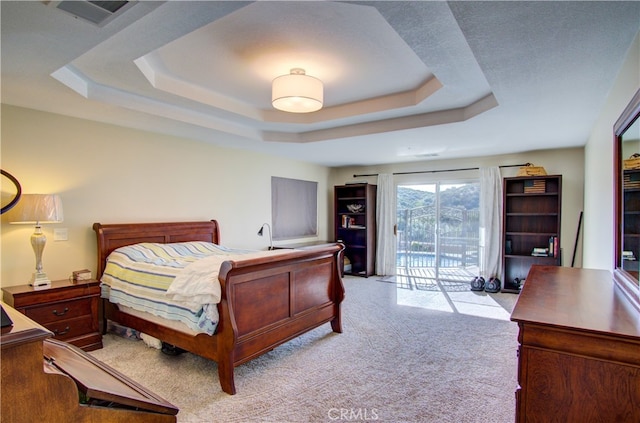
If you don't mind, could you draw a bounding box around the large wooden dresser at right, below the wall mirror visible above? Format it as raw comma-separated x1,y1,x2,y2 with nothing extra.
511,265,640,423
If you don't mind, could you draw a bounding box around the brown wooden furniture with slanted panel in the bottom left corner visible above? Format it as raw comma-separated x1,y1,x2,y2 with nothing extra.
0,304,178,423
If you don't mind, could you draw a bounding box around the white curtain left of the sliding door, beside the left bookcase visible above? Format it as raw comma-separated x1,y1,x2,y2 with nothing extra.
376,174,396,276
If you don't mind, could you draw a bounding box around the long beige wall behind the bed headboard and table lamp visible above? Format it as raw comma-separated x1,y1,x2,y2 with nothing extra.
0,105,333,286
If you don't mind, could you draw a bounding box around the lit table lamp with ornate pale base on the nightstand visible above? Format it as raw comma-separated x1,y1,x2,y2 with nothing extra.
7,194,63,288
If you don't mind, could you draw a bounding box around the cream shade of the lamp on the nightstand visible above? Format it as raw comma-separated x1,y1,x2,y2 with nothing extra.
7,194,64,225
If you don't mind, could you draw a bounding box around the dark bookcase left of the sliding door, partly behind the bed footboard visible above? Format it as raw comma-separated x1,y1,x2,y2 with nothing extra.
334,184,377,277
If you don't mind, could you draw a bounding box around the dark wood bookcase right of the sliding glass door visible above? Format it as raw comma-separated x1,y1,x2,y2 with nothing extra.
502,175,562,293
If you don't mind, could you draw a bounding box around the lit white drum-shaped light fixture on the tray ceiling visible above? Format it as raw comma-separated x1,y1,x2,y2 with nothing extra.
271,68,324,113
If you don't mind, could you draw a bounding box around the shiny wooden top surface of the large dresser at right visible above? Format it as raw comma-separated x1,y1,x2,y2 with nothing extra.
511,266,640,339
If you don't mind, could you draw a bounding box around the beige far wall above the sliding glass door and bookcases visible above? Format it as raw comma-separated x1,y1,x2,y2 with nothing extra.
331,148,584,267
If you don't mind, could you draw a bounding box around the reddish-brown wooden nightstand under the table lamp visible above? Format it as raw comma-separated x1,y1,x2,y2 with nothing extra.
2,279,102,351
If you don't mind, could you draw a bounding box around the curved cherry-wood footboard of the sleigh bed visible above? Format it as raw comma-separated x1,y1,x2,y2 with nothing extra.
216,244,345,394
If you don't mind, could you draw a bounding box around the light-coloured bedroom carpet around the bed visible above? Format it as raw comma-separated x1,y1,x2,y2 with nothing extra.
91,277,517,423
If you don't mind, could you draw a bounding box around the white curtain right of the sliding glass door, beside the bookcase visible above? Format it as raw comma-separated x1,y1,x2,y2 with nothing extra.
480,167,502,280
